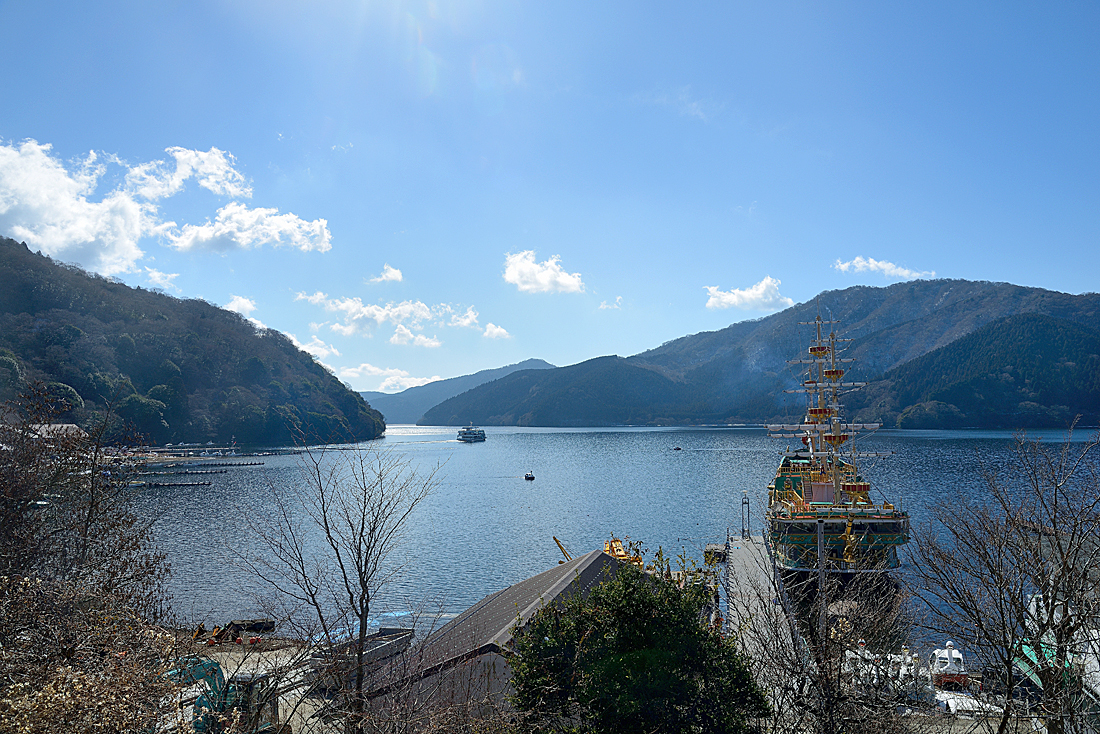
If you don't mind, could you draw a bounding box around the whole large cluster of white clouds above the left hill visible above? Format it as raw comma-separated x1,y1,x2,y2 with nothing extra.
0,140,331,275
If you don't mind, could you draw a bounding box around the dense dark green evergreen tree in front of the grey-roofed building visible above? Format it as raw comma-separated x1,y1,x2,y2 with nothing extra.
512,566,770,733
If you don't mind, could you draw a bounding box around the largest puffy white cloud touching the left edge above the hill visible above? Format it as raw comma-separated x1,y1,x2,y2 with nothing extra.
0,140,151,275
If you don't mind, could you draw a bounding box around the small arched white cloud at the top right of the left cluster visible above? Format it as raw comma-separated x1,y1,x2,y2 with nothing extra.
127,147,252,199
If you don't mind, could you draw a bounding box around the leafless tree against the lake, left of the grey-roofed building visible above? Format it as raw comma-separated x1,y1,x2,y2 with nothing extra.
244,447,439,732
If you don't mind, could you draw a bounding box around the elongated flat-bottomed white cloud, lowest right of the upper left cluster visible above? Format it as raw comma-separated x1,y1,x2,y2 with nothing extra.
167,201,332,252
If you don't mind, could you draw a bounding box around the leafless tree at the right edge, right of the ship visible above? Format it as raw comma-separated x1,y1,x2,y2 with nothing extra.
913,426,1100,734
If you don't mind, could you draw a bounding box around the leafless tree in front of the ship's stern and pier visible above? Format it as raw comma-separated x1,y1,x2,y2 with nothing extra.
726,540,943,734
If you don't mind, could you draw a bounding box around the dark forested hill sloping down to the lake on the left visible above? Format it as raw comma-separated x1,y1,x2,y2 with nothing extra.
0,238,385,446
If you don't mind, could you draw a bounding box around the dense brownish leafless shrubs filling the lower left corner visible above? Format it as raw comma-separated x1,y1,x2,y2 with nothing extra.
0,384,174,732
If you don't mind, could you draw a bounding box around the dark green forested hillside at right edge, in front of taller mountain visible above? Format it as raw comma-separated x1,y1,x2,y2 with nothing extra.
851,314,1100,428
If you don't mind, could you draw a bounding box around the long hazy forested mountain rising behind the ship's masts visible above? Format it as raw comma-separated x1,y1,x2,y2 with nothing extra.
422,280,1100,426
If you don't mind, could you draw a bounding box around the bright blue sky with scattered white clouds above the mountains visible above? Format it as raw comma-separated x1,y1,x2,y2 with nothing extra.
0,0,1100,391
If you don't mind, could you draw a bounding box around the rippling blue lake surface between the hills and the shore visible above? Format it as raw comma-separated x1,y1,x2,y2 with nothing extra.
141,426,1090,623
